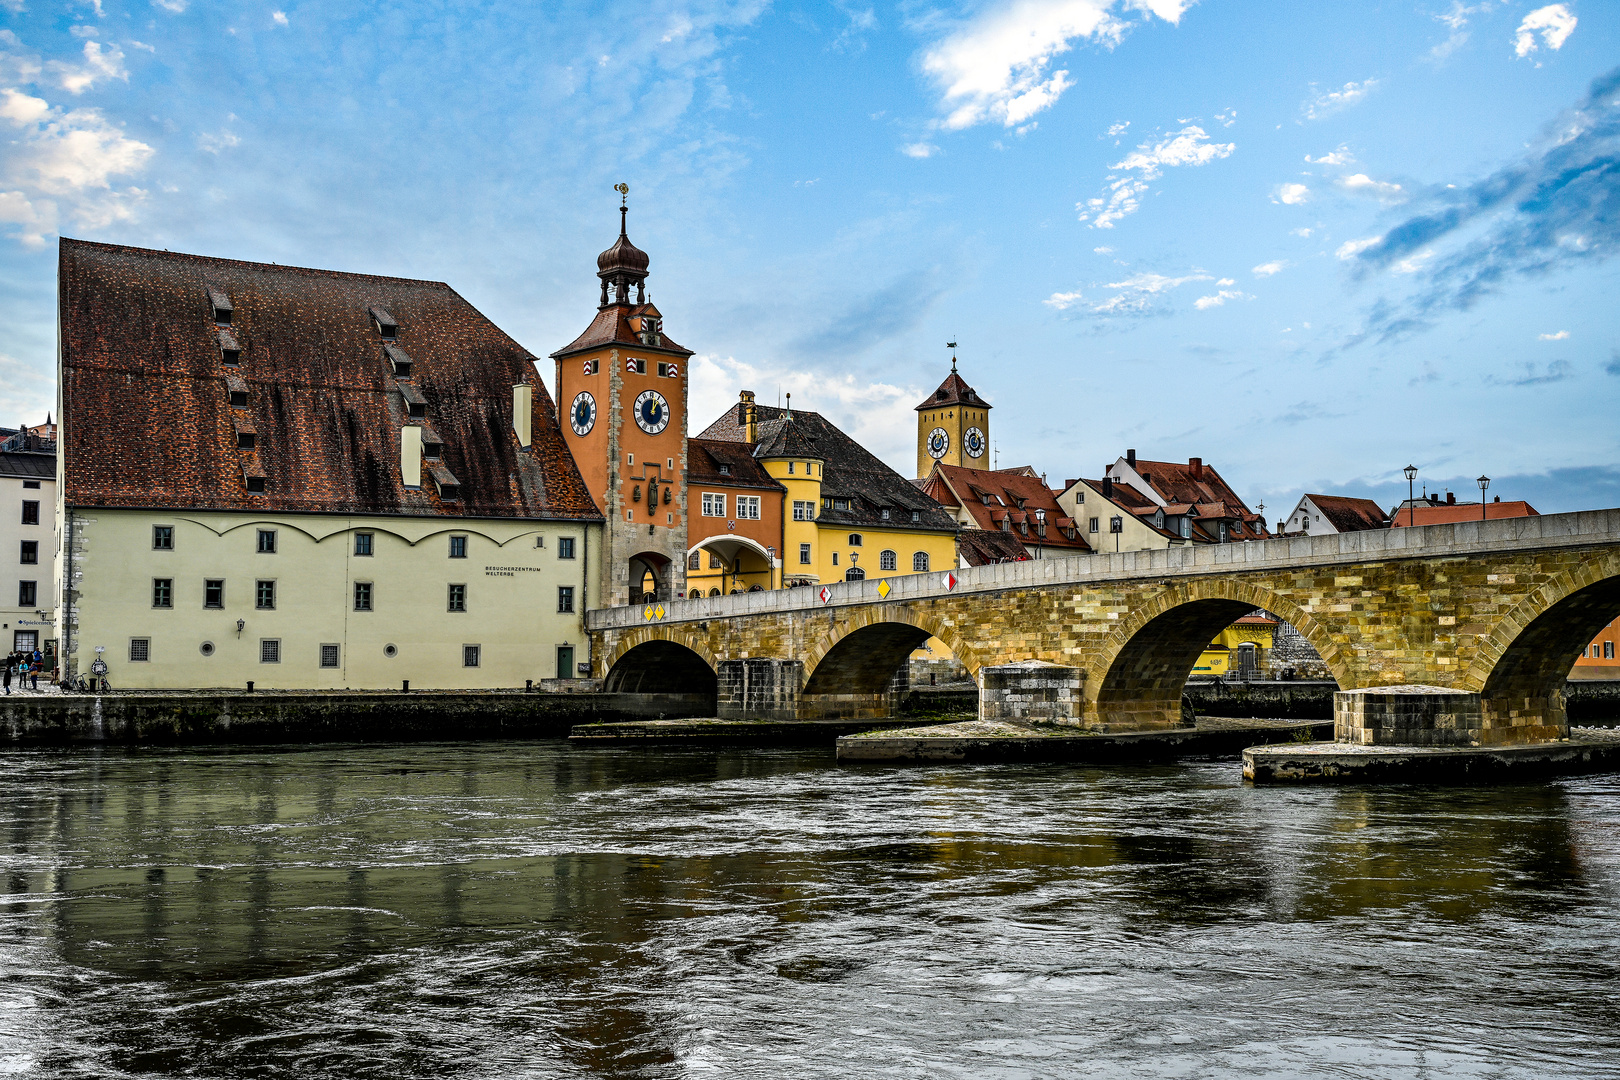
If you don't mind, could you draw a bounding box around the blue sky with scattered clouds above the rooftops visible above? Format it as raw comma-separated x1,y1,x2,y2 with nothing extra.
0,0,1620,521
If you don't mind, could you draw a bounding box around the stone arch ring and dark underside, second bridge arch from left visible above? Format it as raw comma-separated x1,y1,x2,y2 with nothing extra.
804,604,978,695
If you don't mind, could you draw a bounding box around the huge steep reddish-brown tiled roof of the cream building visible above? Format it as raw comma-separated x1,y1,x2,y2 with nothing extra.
58,238,601,520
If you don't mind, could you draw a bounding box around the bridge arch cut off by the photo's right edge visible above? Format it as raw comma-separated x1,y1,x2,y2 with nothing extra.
1463,551,1620,709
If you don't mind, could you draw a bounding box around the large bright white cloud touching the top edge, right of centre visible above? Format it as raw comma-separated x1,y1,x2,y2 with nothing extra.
922,0,1189,131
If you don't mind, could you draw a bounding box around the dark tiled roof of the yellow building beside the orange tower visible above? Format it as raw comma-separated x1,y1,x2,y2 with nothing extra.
698,405,961,533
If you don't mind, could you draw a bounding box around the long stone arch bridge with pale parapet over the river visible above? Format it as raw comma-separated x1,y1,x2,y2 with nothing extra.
585,510,1620,745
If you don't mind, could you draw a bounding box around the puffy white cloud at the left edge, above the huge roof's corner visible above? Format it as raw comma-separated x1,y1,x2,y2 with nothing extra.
0,89,152,248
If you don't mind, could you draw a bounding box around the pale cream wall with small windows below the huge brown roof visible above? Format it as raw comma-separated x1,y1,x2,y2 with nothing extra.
58,510,601,690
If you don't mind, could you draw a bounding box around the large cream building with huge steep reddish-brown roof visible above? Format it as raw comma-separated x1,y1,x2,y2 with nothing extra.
57,240,601,688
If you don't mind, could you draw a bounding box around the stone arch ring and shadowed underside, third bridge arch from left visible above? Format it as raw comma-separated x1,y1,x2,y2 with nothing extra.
1087,578,1356,727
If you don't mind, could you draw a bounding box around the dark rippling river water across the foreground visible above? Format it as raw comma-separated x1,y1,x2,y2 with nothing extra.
0,742,1620,1078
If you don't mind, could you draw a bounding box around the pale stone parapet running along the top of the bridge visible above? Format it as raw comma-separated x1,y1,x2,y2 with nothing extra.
585,508,1620,631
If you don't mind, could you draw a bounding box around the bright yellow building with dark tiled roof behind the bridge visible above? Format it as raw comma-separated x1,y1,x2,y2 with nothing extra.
689,390,959,588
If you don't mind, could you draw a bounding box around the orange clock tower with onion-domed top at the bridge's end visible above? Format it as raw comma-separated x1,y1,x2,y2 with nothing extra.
551,185,692,607
